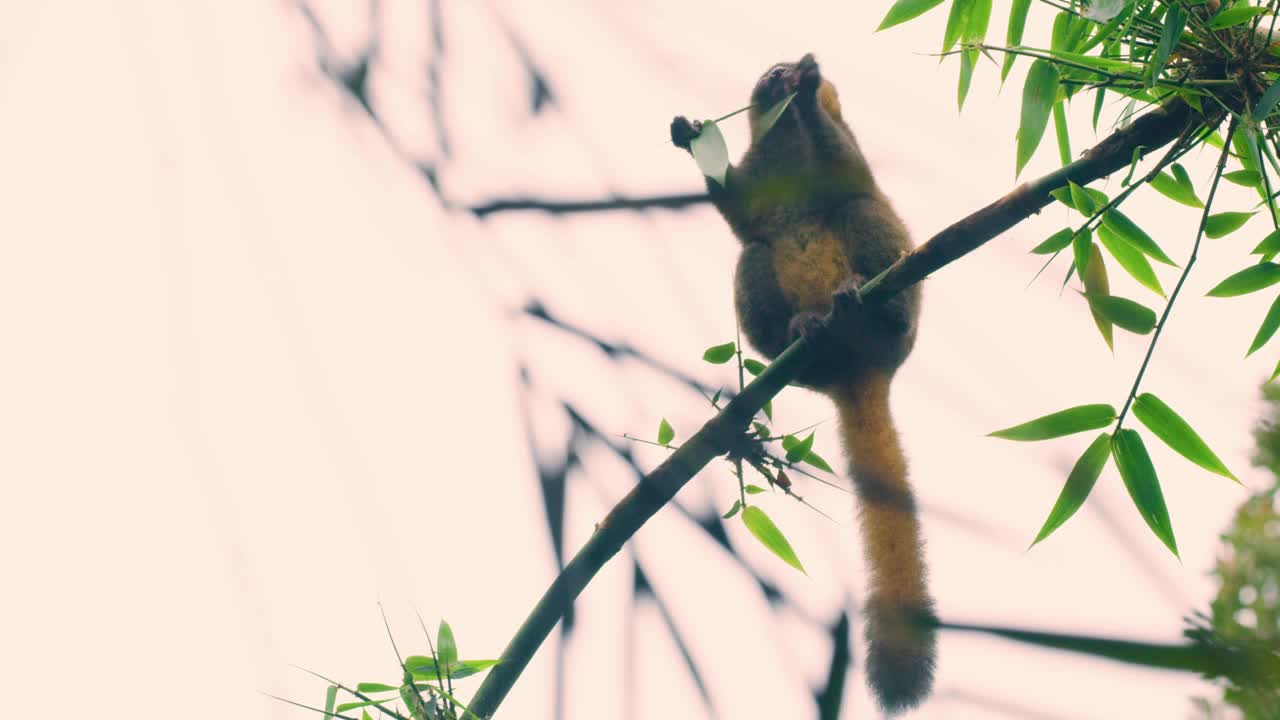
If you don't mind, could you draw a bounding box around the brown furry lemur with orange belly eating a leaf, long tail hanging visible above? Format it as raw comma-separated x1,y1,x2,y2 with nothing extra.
671,54,937,712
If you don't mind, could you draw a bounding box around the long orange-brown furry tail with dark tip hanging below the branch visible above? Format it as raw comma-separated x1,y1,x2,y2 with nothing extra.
831,373,936,712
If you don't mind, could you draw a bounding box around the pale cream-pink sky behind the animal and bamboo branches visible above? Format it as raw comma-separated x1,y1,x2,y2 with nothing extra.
0,0,1276,719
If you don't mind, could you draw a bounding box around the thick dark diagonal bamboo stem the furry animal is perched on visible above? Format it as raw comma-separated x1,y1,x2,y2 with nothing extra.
471,100,1199,719
